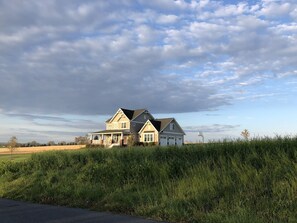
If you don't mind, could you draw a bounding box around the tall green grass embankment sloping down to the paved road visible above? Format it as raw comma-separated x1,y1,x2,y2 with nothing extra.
0,137,297,223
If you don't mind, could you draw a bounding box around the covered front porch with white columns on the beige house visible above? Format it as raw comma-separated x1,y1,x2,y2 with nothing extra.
91,130,130,147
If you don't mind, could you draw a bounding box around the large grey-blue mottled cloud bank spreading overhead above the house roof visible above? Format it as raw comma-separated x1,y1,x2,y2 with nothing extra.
0,0,297,116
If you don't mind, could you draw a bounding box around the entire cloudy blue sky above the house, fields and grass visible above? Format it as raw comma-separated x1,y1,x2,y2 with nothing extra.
0,0,297,142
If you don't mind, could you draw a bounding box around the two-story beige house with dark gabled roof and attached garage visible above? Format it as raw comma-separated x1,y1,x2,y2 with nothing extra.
90,108,185,146
